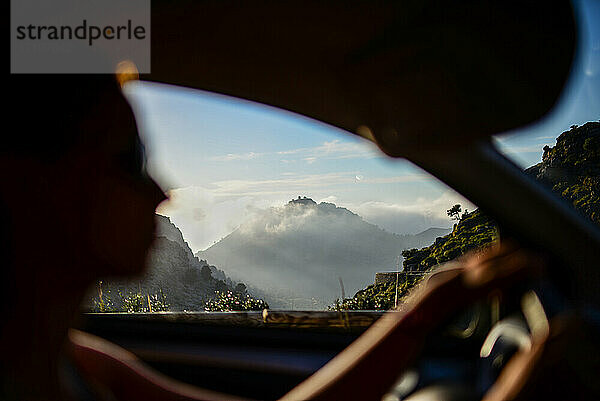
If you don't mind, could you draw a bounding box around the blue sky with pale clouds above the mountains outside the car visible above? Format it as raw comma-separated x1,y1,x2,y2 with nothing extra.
124,0,600,252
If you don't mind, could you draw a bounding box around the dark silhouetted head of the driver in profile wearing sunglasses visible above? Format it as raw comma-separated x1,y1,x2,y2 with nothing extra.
0,75,164,282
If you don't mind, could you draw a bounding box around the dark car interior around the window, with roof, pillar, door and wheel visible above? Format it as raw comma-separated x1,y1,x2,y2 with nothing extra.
5,0,600,401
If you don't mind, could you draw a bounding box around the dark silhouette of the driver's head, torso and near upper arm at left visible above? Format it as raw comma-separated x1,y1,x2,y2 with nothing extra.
0,75,239,400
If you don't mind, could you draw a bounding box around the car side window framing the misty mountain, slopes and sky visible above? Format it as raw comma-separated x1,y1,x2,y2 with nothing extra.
82,81,488,312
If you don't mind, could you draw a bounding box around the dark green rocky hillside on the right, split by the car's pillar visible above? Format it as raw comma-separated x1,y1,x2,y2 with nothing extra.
338,122,600,309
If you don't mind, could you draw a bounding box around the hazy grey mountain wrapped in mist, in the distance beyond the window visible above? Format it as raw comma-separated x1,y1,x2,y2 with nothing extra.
196,197,448,309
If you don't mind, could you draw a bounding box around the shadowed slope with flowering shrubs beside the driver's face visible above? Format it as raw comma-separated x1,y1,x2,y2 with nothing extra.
85,215,267,312
